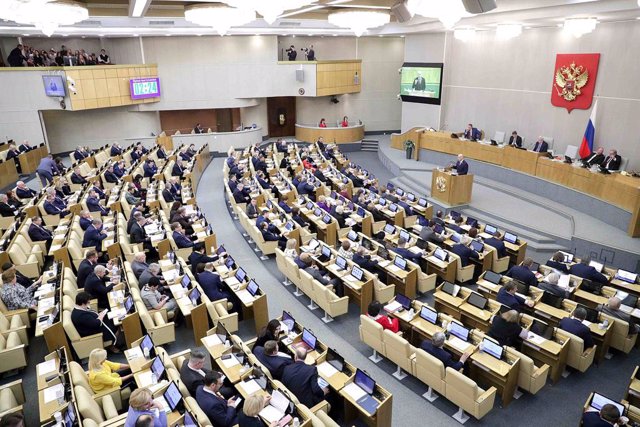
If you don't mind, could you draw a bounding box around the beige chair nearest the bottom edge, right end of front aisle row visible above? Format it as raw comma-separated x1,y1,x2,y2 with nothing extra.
445,368,497,424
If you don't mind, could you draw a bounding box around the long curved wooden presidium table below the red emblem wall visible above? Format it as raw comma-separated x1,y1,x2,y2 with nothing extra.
391,127,640,237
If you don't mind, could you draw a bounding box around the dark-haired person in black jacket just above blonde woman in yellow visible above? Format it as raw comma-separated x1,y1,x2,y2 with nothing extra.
71,292,120,353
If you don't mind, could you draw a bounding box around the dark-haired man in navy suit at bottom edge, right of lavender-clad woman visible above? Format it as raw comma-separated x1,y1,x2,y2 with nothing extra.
196,368,240,427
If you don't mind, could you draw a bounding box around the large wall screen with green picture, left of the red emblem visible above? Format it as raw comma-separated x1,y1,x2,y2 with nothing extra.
400,62,443,105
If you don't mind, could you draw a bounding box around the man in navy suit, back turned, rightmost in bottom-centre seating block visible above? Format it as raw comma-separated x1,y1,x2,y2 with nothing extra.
282,348,329,408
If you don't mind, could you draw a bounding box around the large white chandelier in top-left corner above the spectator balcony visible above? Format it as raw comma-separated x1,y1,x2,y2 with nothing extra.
0,0,89,37
